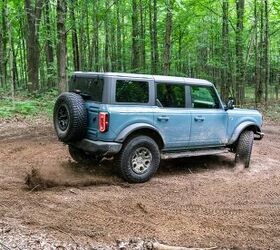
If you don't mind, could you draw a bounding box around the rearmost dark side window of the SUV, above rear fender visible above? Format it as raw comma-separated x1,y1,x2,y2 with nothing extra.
116,80,149,103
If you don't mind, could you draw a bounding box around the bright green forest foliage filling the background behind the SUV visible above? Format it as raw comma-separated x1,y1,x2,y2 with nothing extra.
0,0,280,121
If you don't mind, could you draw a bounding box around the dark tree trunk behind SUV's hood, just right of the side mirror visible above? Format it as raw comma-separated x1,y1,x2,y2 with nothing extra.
236,0,245,105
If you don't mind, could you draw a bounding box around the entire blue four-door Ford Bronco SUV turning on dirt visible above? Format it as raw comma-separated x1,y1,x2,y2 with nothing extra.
53,72,263,182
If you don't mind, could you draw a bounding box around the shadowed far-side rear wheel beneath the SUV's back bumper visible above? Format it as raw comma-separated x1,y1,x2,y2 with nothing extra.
68,146,102,165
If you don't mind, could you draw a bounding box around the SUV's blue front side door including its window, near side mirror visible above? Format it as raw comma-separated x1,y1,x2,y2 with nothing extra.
189,86,228,148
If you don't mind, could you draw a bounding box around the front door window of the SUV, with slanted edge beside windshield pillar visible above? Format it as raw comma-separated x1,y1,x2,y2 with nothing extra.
191,86,220,109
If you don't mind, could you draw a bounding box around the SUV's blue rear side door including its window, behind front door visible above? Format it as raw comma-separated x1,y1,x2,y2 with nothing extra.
154,82,191,149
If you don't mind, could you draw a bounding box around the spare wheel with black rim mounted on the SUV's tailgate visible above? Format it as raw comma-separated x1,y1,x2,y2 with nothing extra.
53,92,87,142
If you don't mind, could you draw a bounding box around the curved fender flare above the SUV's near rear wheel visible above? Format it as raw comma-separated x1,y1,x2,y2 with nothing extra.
115,122,165,145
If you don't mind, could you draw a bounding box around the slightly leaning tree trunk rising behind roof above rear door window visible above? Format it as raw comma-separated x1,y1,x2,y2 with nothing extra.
163,0,174,75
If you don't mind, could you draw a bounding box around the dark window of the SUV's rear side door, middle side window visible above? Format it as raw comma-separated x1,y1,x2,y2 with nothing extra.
157,83,186,108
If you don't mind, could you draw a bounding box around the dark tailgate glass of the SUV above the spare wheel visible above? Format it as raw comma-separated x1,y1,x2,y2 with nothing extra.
69,77,104,102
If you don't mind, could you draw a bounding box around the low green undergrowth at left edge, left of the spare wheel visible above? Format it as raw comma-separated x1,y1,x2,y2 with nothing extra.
0,89,58,119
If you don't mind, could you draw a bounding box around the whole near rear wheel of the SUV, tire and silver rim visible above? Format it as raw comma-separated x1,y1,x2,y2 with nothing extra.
117,136,160,183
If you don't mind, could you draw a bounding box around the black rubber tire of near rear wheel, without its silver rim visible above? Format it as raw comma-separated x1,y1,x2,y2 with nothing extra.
116,136,160,183
